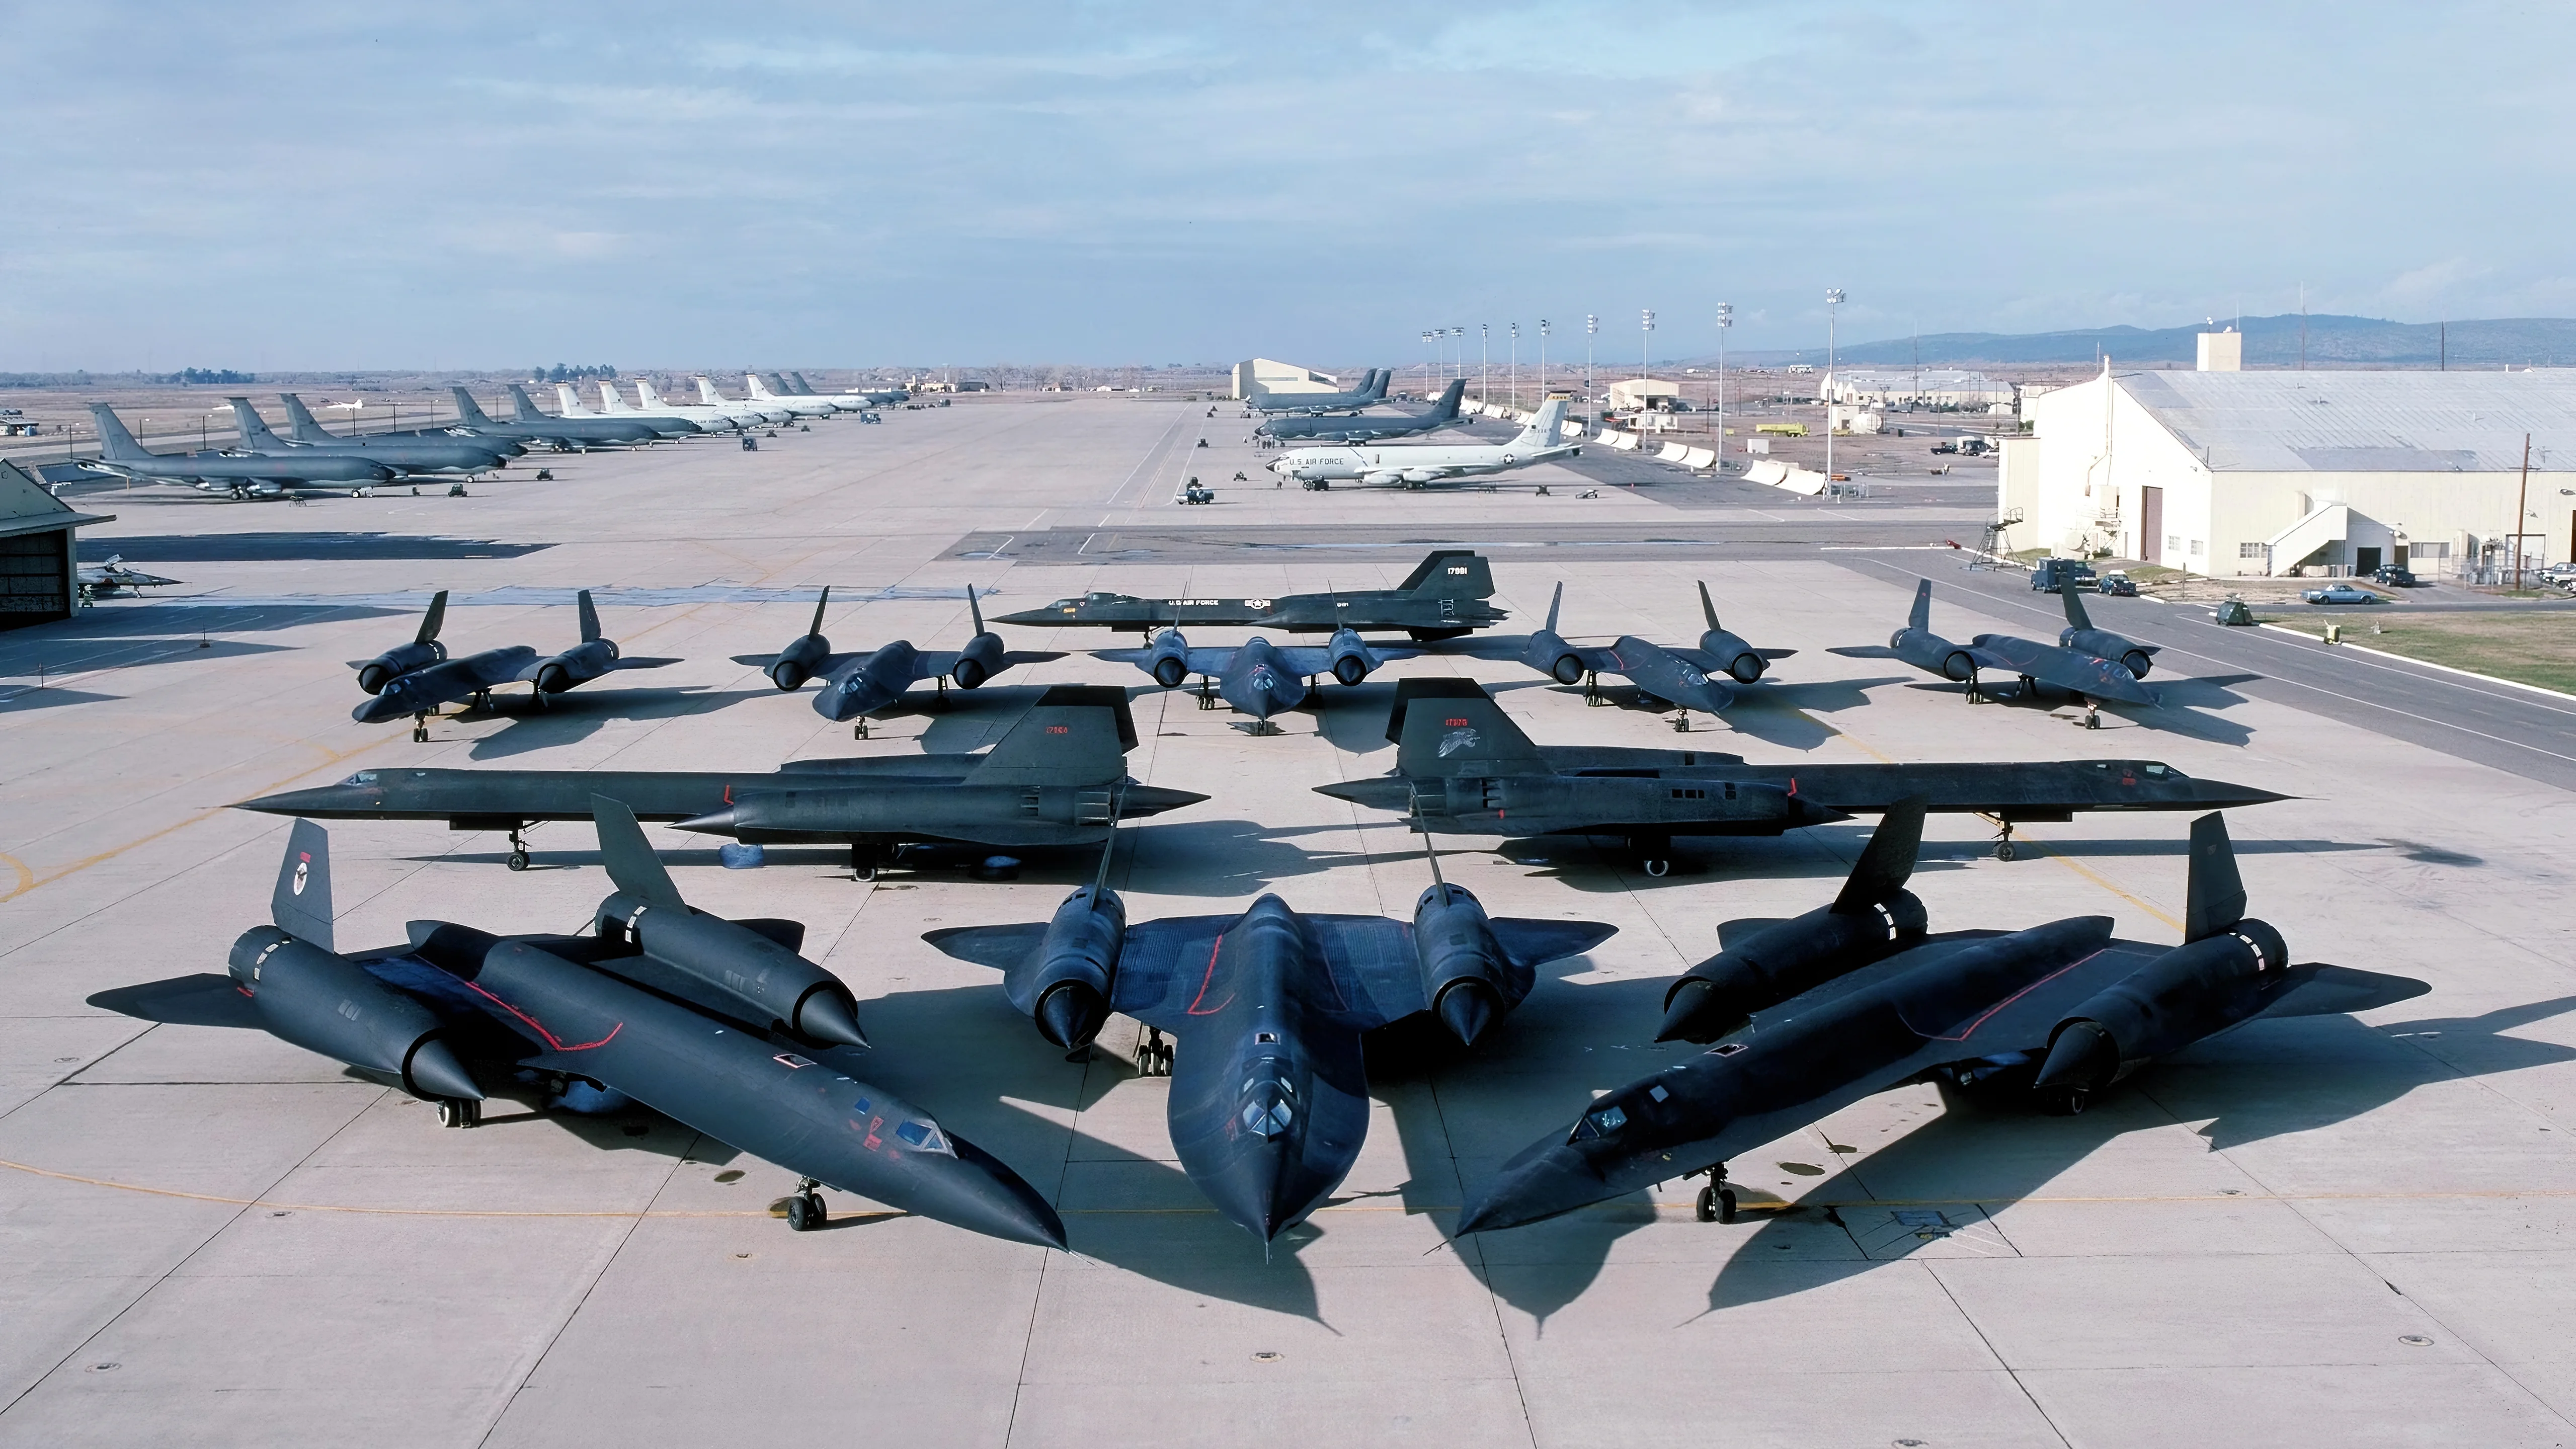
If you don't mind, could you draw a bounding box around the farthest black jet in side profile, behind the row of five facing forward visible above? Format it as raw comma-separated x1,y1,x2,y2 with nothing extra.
994,549,1509,639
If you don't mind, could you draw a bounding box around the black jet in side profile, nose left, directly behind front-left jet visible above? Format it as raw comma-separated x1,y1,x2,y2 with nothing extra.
234,683,1208,879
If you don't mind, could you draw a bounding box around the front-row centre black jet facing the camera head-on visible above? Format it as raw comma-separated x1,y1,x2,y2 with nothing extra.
922,825,1618,1250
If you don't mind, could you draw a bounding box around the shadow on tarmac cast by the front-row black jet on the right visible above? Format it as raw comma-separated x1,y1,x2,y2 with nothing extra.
1648,998,2576,1312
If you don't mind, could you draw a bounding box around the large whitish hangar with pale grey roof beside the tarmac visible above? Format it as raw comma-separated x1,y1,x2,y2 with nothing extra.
1999,333,2576,578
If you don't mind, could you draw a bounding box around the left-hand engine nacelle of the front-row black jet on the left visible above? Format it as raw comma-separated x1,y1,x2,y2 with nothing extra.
232,926,481,1101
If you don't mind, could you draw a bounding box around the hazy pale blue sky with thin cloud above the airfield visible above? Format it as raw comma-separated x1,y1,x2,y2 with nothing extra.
0,0,2576,371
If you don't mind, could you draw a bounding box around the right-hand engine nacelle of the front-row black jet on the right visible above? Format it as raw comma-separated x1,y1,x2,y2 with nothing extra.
2030,920,2290,1111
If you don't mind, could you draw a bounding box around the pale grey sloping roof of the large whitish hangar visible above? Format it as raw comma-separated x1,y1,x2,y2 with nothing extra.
2112,369,2576,472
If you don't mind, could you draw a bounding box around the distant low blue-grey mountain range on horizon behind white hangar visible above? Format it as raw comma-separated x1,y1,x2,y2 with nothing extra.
1739,312,2576,369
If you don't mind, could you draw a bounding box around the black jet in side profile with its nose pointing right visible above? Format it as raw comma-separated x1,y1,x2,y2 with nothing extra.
1314,678,2288,876
